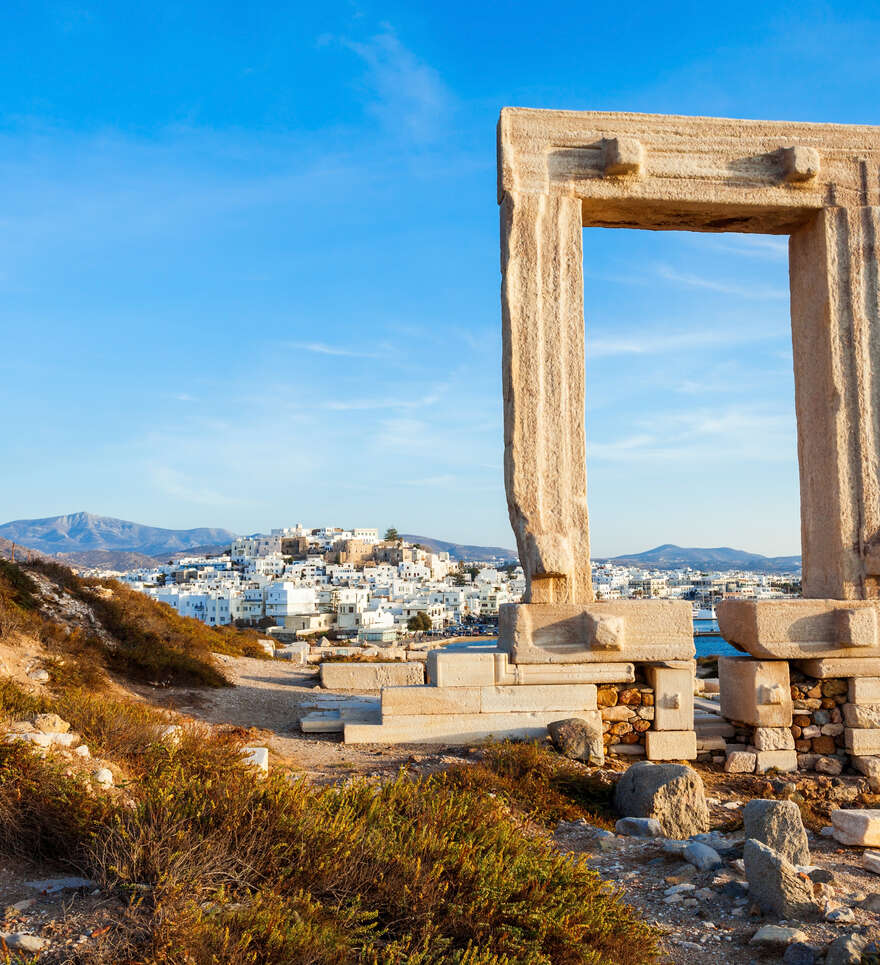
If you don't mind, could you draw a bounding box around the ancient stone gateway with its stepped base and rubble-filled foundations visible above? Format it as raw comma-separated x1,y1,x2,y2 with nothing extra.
336,108,880,773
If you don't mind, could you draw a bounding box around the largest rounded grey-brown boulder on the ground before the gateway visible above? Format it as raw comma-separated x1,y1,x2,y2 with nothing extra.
614,761,709,838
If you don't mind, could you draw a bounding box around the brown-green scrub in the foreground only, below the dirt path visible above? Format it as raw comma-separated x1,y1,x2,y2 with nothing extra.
0,712,657,965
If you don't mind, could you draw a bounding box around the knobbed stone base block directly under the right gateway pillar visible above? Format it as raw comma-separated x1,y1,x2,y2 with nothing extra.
716,600,880,660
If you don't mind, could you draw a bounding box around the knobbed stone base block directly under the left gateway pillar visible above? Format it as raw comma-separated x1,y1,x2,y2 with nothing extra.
498,600,694,664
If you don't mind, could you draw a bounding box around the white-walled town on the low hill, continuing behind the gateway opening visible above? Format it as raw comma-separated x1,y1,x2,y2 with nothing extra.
69,525,799,644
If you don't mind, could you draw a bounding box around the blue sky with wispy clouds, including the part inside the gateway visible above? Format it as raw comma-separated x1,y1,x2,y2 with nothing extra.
0,0,880,555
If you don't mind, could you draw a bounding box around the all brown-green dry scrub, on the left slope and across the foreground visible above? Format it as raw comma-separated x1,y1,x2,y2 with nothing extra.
0,564,658,965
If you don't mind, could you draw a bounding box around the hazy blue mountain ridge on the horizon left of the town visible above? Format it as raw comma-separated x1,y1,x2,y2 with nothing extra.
0,513,235,565
